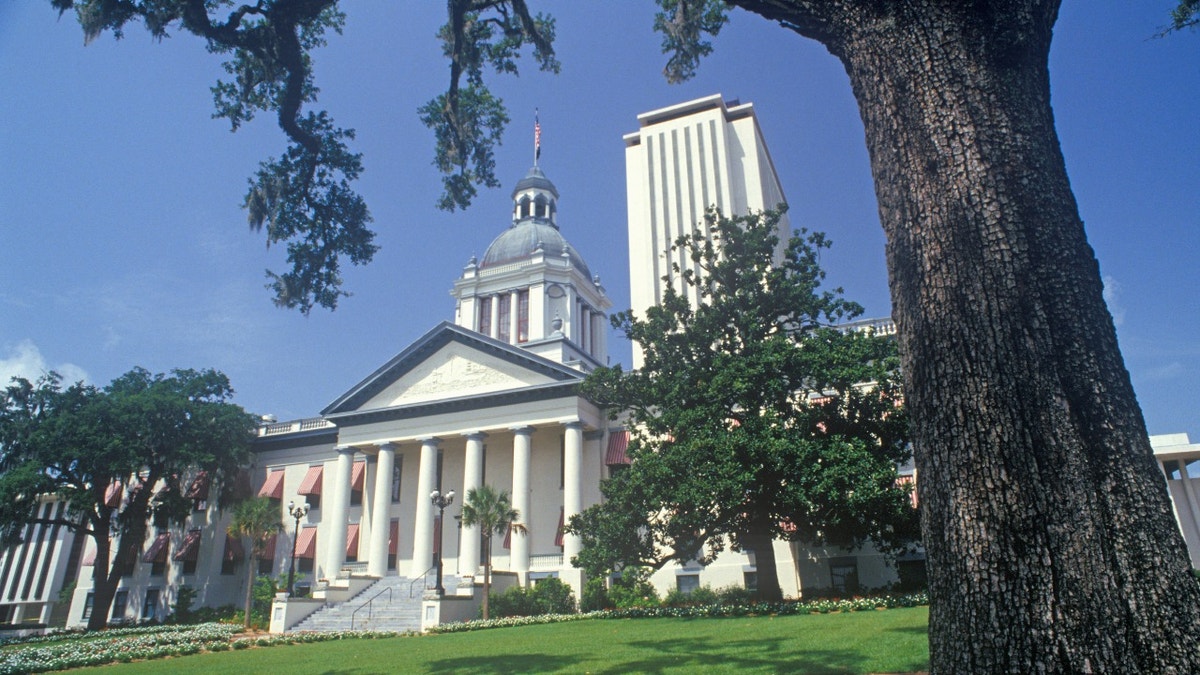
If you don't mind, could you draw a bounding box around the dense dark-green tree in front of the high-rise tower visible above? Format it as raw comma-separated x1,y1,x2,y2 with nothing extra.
571,211,917,601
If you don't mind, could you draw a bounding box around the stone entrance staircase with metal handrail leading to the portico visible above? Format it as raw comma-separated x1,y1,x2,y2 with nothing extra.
292,569,455,632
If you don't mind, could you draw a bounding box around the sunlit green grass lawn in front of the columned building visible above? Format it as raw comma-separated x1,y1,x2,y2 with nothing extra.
84,607,929,675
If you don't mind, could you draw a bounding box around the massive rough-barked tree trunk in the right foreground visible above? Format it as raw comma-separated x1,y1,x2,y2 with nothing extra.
737,0,1200,673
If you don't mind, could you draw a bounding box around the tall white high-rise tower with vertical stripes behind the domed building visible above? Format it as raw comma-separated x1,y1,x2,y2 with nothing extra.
624,94,791,368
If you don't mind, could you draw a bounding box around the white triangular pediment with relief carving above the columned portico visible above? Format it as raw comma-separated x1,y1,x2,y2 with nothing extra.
323,323,582,414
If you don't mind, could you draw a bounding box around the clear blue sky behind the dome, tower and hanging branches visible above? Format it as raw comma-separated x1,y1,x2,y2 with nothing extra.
0,0,1200,441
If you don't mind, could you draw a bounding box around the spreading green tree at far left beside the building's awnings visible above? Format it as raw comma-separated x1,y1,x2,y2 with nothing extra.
0,369,254,629
